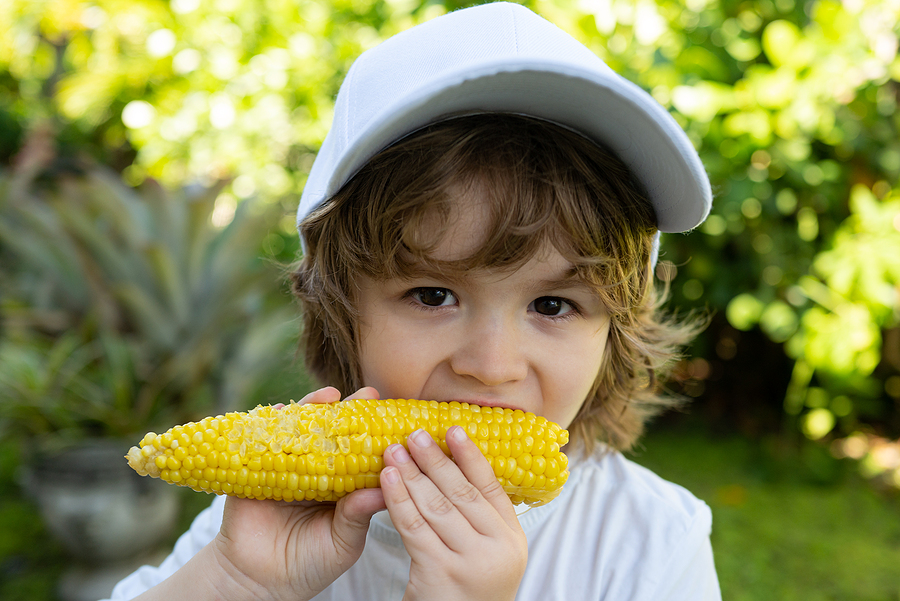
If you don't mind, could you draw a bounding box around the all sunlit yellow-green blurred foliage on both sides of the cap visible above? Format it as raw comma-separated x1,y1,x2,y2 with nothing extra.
0,0,900,454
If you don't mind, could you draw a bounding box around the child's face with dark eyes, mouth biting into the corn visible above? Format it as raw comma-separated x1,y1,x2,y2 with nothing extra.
358,185,609,427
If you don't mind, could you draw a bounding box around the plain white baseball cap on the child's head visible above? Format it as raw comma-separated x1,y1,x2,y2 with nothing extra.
297,2,712,241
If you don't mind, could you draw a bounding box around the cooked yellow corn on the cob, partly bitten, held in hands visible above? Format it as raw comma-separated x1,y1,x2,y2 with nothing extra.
126,399,569,505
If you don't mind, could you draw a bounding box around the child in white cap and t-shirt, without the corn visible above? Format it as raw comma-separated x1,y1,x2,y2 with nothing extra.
113,3,720,601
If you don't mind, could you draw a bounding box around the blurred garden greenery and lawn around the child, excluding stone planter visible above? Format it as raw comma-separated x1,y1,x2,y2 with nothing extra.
0,0,900,601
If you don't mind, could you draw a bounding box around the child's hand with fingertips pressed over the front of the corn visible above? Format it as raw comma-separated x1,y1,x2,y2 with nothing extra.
381,426,528,601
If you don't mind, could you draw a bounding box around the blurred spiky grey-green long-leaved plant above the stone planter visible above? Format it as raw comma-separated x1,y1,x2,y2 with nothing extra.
0,127,296,440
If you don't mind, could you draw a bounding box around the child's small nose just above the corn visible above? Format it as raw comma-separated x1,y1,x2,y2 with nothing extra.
451,319,528,386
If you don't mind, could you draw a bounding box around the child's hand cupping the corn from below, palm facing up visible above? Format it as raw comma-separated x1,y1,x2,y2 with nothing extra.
214,387,385,599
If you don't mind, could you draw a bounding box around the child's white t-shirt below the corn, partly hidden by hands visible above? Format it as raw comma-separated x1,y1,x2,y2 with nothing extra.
102,449,721,601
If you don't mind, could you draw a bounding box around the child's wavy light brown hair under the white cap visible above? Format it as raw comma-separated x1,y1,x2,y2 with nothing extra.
293,114,698,451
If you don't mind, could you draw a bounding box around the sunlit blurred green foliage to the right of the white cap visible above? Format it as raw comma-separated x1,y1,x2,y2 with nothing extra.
541,0,900,438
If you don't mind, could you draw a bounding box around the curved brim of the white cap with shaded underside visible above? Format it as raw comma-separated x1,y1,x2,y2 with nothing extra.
319,59,712,232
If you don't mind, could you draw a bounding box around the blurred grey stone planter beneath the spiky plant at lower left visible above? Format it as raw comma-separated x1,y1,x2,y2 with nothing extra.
23,440,179,601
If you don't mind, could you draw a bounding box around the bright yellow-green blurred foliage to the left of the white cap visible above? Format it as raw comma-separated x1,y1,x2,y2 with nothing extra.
0,0,444,198
